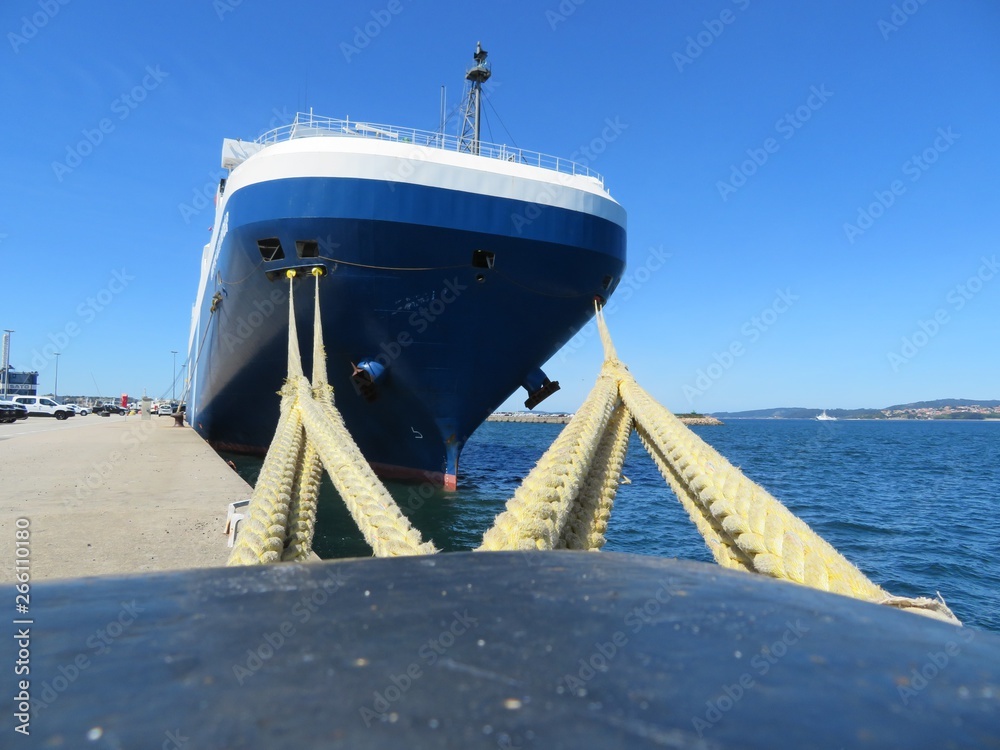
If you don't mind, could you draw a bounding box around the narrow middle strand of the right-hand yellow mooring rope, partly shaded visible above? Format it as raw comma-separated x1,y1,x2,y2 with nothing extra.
556,403,632,551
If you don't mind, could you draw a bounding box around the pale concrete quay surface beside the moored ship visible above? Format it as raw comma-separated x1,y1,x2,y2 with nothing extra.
0,415,252,583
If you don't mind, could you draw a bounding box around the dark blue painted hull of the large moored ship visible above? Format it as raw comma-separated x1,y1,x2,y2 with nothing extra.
189,138,625,486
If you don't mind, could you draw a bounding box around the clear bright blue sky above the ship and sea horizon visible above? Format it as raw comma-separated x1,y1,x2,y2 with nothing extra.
0,0,1000,411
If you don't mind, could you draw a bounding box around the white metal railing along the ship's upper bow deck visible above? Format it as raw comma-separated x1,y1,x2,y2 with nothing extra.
256,112,604,187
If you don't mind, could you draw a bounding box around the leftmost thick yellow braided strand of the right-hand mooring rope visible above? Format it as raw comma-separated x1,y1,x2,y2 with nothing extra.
479,366,618,550
